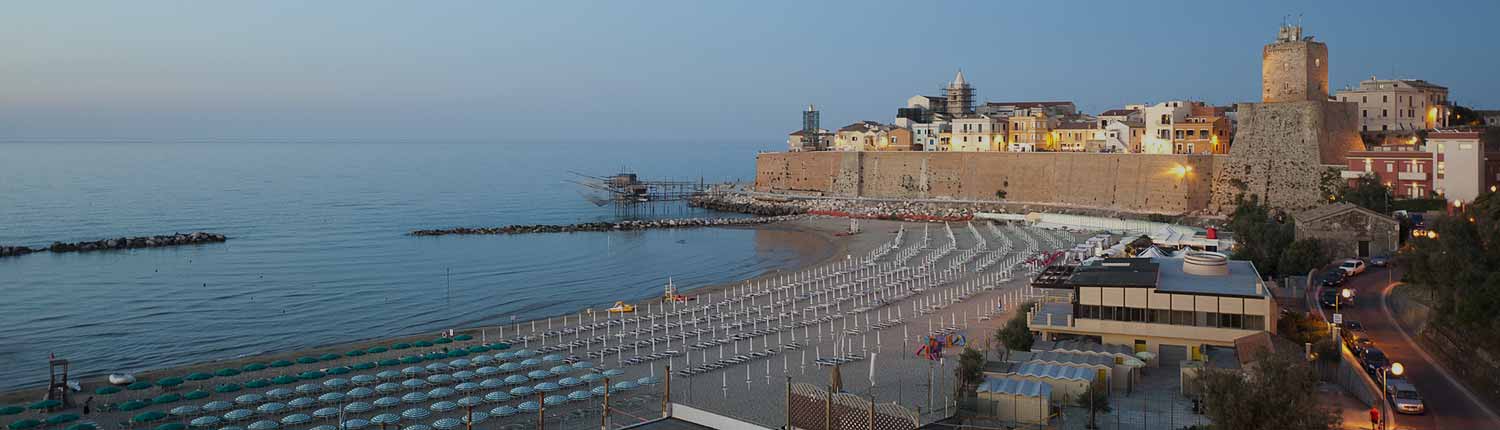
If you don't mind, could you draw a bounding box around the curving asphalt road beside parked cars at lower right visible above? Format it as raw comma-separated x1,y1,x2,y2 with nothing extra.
1314,267,1500,429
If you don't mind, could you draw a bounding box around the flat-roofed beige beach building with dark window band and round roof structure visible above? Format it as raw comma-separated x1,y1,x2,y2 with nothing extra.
1028,252,1278,367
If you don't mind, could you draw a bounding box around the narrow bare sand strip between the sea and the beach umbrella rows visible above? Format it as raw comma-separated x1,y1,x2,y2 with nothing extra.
0,217,884,405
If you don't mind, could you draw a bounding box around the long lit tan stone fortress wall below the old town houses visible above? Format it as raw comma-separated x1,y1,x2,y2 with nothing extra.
756,151,1223,213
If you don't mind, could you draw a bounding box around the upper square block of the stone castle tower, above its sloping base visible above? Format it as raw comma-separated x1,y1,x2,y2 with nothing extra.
1260,25,1328,103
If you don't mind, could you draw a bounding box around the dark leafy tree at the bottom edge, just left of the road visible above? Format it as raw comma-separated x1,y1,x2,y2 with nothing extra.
1194,352,1343,430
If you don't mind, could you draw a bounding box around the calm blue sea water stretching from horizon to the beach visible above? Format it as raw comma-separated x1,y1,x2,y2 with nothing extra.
0,142,818,388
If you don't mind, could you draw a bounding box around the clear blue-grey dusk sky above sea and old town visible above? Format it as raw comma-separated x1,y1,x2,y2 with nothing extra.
0,0,1500,144
